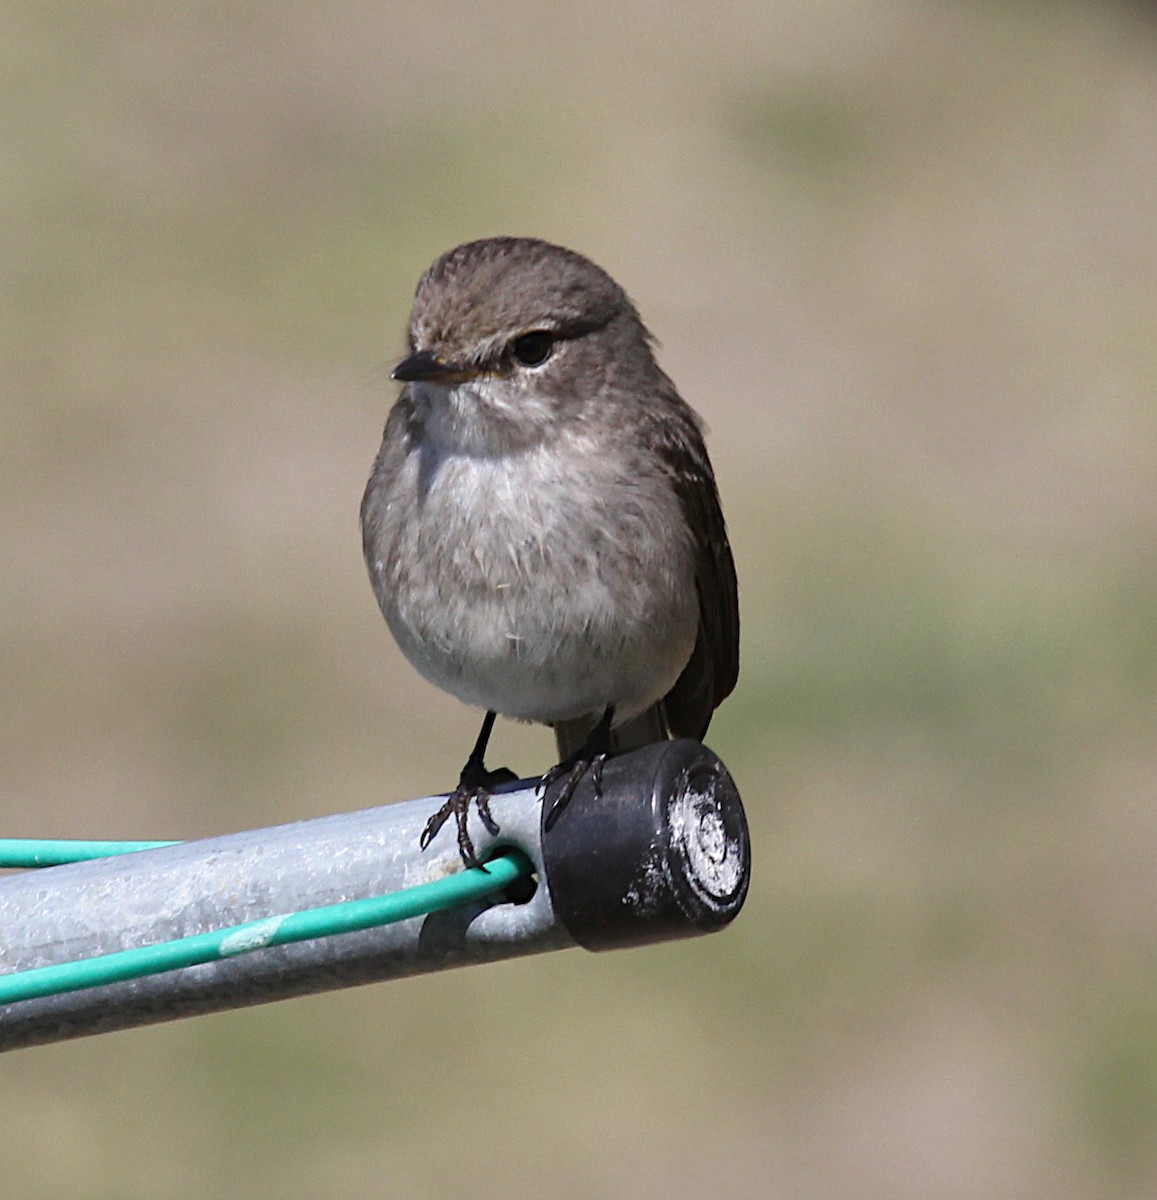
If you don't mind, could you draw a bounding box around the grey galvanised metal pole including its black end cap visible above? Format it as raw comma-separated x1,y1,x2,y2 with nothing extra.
0,742,750,1050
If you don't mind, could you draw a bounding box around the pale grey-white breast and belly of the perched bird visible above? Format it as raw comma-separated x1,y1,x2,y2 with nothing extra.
367,439,699,720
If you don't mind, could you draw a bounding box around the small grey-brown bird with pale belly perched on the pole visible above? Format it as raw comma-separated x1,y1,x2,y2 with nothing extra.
361,238,739,865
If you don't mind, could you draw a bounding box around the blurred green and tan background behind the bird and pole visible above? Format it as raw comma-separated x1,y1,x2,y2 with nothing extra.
0,0,1157,1200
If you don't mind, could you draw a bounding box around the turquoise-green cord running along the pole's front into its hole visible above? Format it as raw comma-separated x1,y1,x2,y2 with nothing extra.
0,842,534,1004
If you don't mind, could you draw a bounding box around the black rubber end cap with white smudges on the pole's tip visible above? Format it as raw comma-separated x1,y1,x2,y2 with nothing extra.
542,738,751,950
